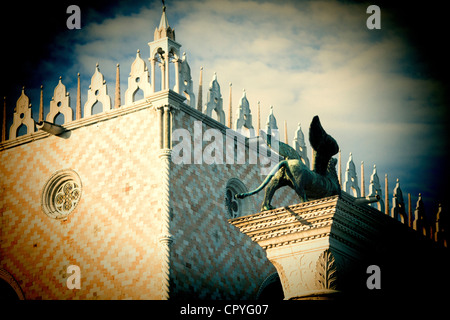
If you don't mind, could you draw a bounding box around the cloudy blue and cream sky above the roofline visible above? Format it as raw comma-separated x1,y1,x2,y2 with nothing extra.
1,0,448,218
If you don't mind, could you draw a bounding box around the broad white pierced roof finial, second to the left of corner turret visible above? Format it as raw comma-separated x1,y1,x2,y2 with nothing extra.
84,63,111,117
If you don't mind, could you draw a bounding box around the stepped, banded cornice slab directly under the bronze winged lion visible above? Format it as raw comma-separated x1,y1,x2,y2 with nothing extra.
229,192,395,250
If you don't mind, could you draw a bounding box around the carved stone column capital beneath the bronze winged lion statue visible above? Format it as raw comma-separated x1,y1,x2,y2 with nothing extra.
229,192,390,299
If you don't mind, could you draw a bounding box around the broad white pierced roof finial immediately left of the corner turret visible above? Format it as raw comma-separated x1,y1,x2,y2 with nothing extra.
125,50,152,105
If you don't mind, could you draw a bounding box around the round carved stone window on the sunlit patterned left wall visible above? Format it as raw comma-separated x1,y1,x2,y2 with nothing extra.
41,170,81,219
